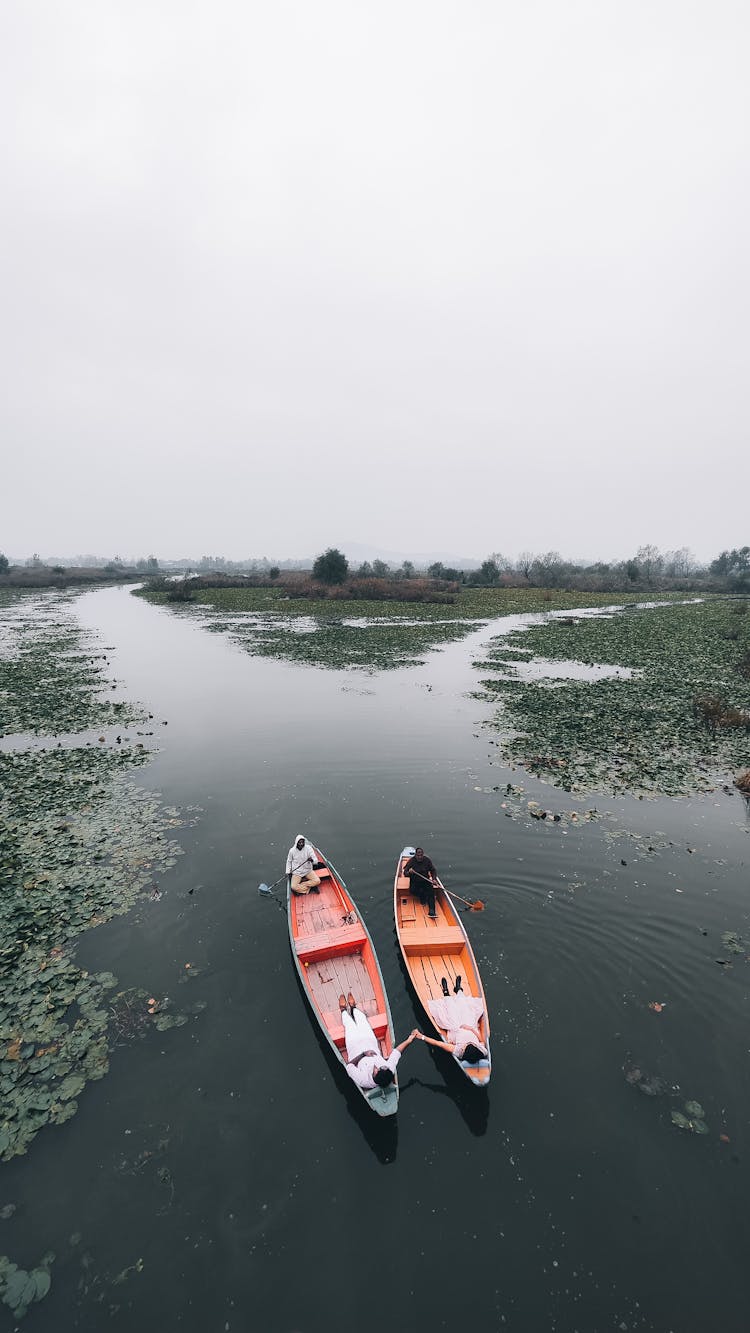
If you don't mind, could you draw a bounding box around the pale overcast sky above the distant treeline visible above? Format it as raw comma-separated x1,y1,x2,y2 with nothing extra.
0,0,750,559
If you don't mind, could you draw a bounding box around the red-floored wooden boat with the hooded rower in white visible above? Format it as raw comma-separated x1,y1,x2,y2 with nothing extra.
286,848,398,1116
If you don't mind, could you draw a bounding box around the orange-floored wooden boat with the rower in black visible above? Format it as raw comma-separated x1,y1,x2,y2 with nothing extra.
393,846,492,1088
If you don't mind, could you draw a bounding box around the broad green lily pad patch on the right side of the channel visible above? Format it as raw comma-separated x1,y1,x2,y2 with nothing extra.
481,599,750,796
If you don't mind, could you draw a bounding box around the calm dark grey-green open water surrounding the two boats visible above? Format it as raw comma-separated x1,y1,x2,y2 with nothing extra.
0,589,750,1333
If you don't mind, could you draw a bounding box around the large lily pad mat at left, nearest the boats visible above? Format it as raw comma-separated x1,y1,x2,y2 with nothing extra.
0,748,187,1160
